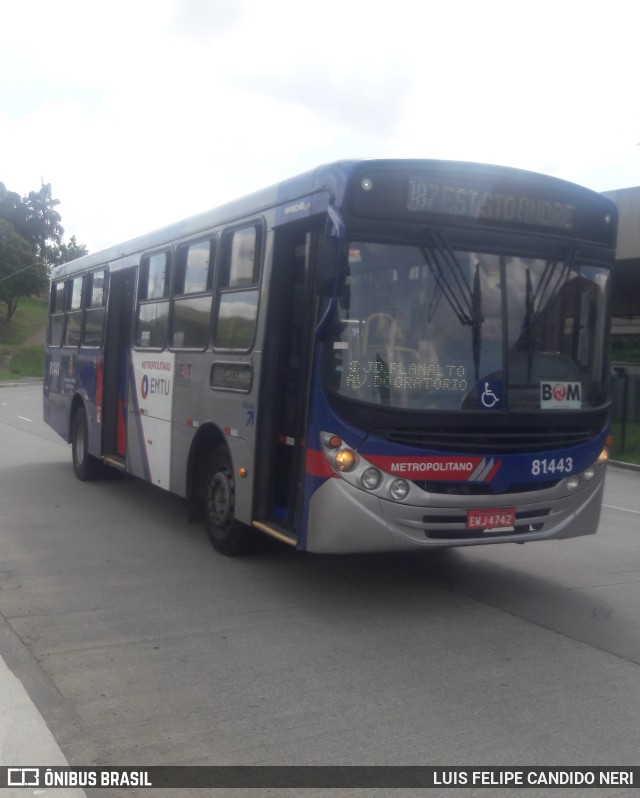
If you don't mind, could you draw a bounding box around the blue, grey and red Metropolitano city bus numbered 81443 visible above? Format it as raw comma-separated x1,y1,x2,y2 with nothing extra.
44,159,617,555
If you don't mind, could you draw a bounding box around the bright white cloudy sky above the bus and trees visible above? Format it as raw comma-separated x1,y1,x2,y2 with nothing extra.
0,0,640,252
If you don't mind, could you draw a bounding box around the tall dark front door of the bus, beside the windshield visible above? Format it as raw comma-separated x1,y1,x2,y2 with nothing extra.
257,227,316,537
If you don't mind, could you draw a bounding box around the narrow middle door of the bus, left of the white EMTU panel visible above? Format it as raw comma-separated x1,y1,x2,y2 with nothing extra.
102,269,136,469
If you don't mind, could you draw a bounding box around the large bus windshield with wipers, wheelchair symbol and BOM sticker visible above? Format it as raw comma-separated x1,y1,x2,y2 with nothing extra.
325,234,609,411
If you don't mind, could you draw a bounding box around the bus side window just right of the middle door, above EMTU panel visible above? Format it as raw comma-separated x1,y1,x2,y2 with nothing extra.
135,252,171,349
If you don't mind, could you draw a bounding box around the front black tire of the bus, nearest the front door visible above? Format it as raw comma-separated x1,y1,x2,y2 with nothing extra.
204,446,256,557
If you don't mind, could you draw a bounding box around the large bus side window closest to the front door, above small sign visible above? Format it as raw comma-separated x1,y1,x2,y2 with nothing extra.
213,225,261,352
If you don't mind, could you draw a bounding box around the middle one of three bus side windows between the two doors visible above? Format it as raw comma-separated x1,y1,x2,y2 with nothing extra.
171,241,216,350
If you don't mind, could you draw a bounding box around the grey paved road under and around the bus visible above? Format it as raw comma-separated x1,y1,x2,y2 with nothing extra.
0,386,640,798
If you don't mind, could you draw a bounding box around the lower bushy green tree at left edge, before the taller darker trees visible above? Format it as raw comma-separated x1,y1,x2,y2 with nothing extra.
0,219,49,321
